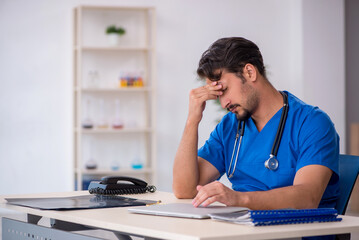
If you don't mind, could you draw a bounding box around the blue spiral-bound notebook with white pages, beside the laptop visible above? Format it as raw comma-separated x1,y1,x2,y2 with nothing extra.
210,208,342,226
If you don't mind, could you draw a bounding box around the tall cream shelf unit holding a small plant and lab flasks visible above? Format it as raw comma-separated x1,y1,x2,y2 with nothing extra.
73,6,156,190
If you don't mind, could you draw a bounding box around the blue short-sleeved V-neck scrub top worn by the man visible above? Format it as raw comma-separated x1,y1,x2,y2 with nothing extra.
198,92,339,207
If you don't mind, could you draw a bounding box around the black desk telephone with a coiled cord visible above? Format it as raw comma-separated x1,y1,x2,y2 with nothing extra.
88,176,156,195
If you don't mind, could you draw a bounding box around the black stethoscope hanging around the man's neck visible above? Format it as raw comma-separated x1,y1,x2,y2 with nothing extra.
227,92,289,178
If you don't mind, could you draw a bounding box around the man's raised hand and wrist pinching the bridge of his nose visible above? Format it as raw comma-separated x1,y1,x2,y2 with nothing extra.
188,80,223,123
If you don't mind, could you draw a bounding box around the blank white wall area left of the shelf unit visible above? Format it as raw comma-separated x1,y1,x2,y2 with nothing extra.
0,0,72,194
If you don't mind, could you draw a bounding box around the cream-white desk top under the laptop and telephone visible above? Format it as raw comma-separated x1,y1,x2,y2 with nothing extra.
0,192,359,240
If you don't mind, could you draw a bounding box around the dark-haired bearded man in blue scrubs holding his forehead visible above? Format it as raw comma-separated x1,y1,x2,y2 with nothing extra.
173,37,339,209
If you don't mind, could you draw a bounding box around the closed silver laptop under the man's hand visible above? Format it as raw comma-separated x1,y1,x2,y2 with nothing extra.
128,203,248,219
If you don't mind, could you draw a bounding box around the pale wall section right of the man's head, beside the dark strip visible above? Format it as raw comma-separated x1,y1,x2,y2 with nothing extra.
302,0,345,152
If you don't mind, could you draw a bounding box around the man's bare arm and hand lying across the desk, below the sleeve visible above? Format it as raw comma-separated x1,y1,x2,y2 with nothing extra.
192,165,333,210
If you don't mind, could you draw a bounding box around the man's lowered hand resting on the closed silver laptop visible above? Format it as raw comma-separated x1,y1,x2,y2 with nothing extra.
192,181,240,207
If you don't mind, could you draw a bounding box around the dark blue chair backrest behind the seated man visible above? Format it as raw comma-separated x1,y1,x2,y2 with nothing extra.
336,154,359,215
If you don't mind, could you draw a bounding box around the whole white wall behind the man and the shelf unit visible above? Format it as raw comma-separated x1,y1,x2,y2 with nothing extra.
0,0,345,194
